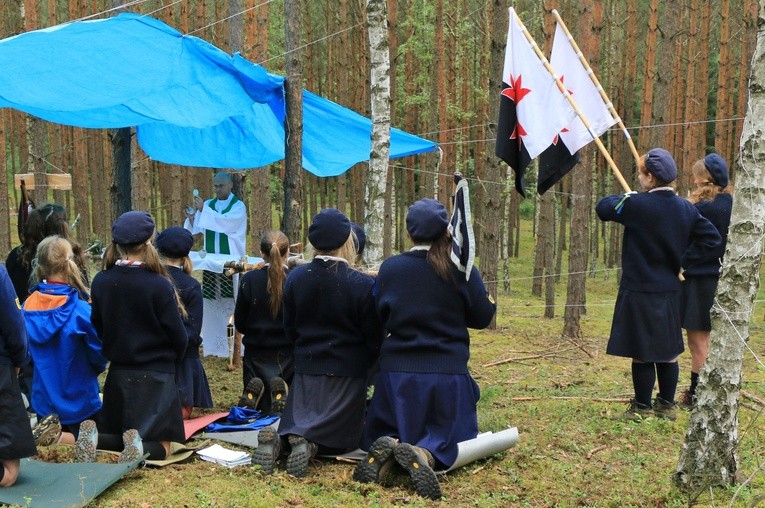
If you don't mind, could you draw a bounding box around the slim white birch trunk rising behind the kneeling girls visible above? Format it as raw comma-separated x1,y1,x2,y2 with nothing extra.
364,0,390,266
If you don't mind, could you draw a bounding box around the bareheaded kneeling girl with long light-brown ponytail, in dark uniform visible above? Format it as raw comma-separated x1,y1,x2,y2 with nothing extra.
234,231,294,414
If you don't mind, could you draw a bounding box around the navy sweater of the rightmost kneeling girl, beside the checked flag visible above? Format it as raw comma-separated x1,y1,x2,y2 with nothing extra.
375,250,497,374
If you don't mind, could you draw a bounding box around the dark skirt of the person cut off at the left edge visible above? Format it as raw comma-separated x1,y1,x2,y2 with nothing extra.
0,365,37,460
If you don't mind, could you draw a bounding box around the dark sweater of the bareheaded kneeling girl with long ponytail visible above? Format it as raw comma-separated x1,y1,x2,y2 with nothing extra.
234,265,292,358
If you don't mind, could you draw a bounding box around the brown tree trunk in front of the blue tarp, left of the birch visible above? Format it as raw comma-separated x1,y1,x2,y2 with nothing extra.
282,0,303,242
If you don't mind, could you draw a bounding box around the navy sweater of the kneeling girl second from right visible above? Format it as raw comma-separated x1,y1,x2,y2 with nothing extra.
282,258,383,378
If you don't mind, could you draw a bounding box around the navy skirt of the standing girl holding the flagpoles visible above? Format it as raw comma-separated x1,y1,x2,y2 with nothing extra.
606,288,684,363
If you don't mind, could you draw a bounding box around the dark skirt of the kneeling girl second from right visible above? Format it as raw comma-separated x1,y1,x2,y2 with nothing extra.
279,373,367,450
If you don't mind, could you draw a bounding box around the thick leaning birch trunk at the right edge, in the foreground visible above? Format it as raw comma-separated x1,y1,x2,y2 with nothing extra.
674,0,765,493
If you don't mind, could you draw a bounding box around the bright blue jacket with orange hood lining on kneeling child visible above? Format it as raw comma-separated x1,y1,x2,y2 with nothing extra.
22,283,106,425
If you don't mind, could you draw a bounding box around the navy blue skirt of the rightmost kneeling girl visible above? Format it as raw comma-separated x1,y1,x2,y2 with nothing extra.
361,370,481,469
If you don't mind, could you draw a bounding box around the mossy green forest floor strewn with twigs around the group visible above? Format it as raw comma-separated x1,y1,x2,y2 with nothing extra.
29,232,765,508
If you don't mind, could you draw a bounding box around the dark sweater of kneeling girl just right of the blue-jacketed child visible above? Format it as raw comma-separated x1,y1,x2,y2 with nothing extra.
90,266,188,373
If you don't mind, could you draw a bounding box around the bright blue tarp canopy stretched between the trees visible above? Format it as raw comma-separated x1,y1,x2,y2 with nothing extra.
0,13,437,176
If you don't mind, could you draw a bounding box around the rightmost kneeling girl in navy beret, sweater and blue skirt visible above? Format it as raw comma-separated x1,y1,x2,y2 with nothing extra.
354,199,496,499
